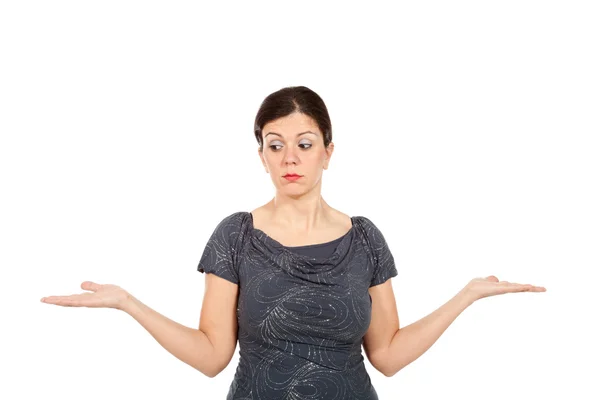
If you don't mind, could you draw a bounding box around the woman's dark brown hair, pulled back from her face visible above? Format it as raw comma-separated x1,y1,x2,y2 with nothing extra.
254,86,332,151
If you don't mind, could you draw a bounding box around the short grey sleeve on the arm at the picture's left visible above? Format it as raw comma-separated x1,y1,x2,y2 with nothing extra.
198,213,243,284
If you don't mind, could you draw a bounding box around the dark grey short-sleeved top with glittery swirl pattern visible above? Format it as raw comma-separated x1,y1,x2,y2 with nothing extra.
197,211,398,400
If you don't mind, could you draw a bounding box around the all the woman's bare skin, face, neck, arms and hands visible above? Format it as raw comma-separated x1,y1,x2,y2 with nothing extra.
41,113,546,377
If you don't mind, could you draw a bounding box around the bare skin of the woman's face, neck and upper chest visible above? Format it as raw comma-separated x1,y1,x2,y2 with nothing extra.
252,113,352,241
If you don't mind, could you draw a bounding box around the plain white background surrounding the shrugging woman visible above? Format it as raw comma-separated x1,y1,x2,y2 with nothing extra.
0,0,600,400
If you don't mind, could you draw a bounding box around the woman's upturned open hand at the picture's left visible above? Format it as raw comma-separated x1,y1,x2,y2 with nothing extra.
41,281,129,310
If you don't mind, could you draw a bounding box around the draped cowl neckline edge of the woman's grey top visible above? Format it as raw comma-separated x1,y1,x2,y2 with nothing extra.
247,211,357,264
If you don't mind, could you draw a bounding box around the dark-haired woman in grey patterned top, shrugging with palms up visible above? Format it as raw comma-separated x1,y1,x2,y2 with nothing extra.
42,86,545,400
